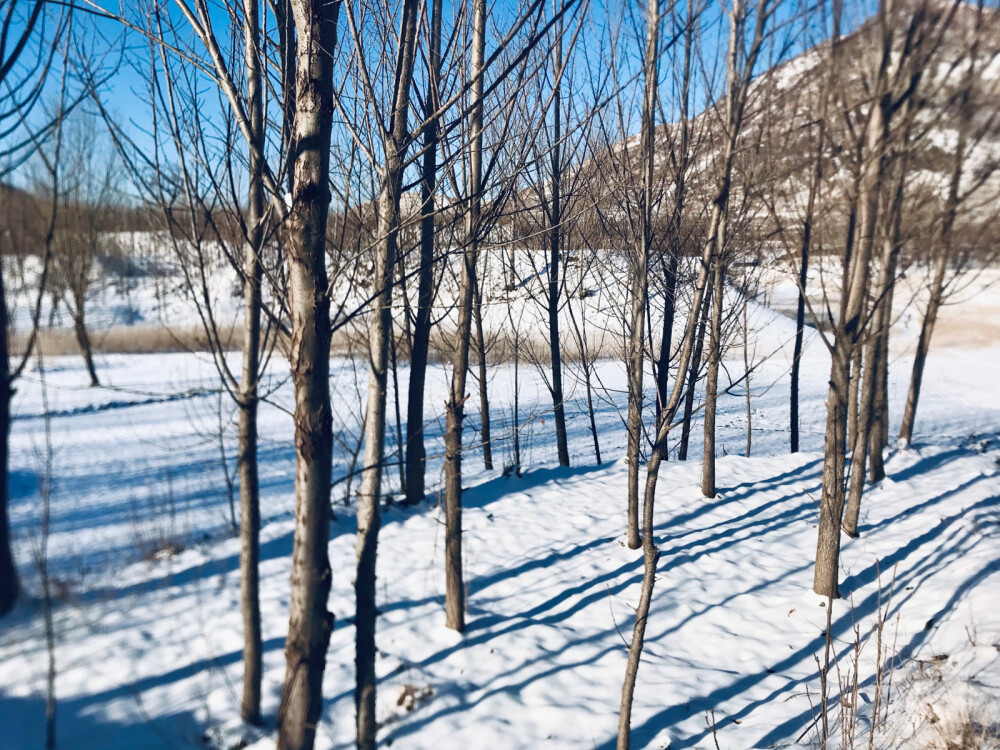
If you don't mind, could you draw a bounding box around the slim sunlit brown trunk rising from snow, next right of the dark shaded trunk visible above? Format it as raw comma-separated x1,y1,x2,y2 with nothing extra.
444,0,486,633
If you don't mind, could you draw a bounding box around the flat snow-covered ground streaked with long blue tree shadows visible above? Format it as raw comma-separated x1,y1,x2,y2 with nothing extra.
0,280,1000,750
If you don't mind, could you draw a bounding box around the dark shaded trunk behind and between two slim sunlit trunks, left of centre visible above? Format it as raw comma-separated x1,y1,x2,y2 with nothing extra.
406,0,442,505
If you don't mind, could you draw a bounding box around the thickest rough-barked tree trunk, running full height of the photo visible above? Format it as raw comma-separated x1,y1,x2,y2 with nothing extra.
278,0,340,750
